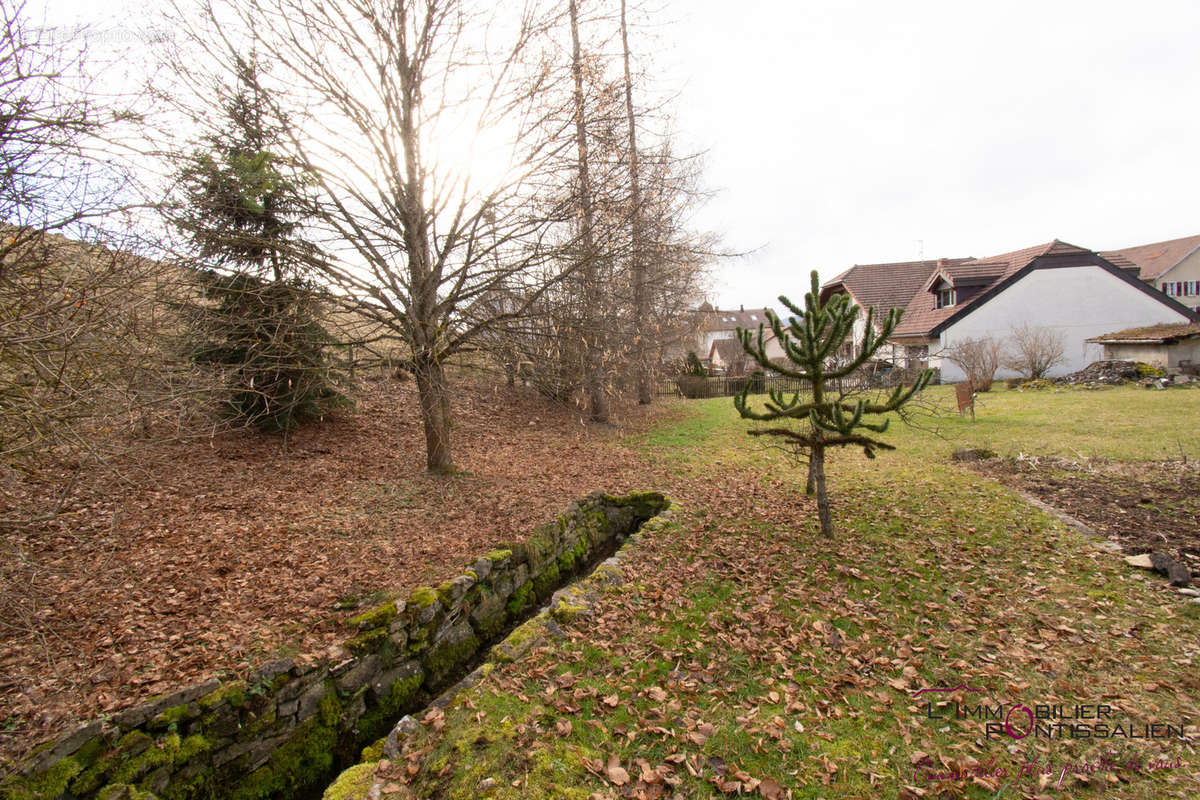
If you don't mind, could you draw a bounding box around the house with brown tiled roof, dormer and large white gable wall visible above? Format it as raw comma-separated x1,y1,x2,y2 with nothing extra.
822,240,1200,383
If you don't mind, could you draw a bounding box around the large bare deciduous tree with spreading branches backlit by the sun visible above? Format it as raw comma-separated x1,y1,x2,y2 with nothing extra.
168,0,571,473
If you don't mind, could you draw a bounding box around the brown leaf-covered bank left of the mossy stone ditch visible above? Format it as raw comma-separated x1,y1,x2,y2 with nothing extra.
0,380,670,759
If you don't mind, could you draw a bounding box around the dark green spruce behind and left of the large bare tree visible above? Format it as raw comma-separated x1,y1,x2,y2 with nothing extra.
173,60,347,431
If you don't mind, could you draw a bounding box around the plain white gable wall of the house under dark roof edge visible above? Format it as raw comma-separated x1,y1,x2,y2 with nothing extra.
930,265,1188,383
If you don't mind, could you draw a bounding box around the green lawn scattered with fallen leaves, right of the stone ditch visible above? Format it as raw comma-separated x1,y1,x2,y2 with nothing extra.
374,390,1200,798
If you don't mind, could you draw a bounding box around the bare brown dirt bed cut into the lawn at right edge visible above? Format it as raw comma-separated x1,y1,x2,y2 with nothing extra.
973,458,1200,577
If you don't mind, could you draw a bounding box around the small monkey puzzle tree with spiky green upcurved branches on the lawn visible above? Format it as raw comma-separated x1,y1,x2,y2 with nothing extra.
733,270,934,537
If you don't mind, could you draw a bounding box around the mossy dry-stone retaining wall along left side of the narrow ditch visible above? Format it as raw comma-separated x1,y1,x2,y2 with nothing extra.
0,492,667,800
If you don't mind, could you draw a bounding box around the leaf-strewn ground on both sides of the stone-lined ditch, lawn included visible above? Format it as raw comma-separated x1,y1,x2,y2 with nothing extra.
0,384,1200,799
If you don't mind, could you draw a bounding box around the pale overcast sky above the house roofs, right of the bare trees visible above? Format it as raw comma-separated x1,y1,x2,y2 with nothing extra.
30,0,1200,307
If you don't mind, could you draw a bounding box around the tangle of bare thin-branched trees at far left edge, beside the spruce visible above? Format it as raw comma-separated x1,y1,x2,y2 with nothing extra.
0,0,186,522
